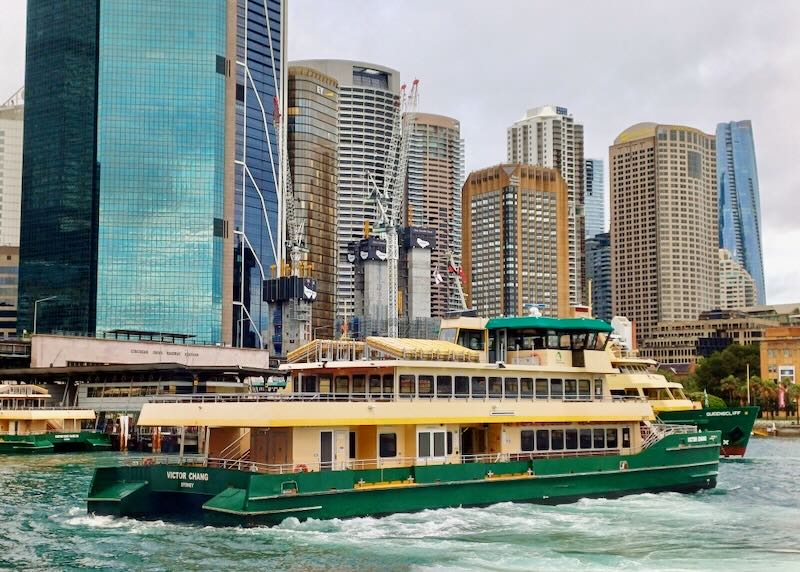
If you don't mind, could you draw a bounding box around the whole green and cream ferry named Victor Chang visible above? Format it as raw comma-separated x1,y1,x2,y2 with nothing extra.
87,318,721,526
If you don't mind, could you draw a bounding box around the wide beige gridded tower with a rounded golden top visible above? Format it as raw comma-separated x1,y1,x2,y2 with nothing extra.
609,123,719,341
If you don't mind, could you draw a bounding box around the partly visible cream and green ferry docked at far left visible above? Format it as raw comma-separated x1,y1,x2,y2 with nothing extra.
0,384,111,454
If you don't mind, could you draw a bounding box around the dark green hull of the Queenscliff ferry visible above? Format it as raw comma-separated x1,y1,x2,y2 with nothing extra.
658,406,759,457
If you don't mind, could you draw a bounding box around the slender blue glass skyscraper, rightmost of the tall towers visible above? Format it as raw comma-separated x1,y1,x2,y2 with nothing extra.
717,120,767,304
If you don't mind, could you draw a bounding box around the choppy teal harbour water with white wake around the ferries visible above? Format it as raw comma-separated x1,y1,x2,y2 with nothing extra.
0,439,800,572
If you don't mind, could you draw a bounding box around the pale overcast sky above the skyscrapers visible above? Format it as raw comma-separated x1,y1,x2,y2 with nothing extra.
0,0,800,304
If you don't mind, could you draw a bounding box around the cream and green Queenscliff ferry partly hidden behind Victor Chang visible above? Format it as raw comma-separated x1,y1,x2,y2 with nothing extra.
609,354,759,457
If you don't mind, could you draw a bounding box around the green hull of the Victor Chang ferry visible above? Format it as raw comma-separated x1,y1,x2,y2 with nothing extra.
87,433,721,526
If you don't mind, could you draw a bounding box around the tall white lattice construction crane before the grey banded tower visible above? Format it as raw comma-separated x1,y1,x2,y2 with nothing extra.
366,79,419,338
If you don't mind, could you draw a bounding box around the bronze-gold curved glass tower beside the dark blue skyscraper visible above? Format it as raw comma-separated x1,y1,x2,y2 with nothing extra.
286,65,339,337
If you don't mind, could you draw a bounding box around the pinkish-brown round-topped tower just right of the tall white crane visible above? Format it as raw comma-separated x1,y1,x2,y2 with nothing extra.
406,113,464,318
